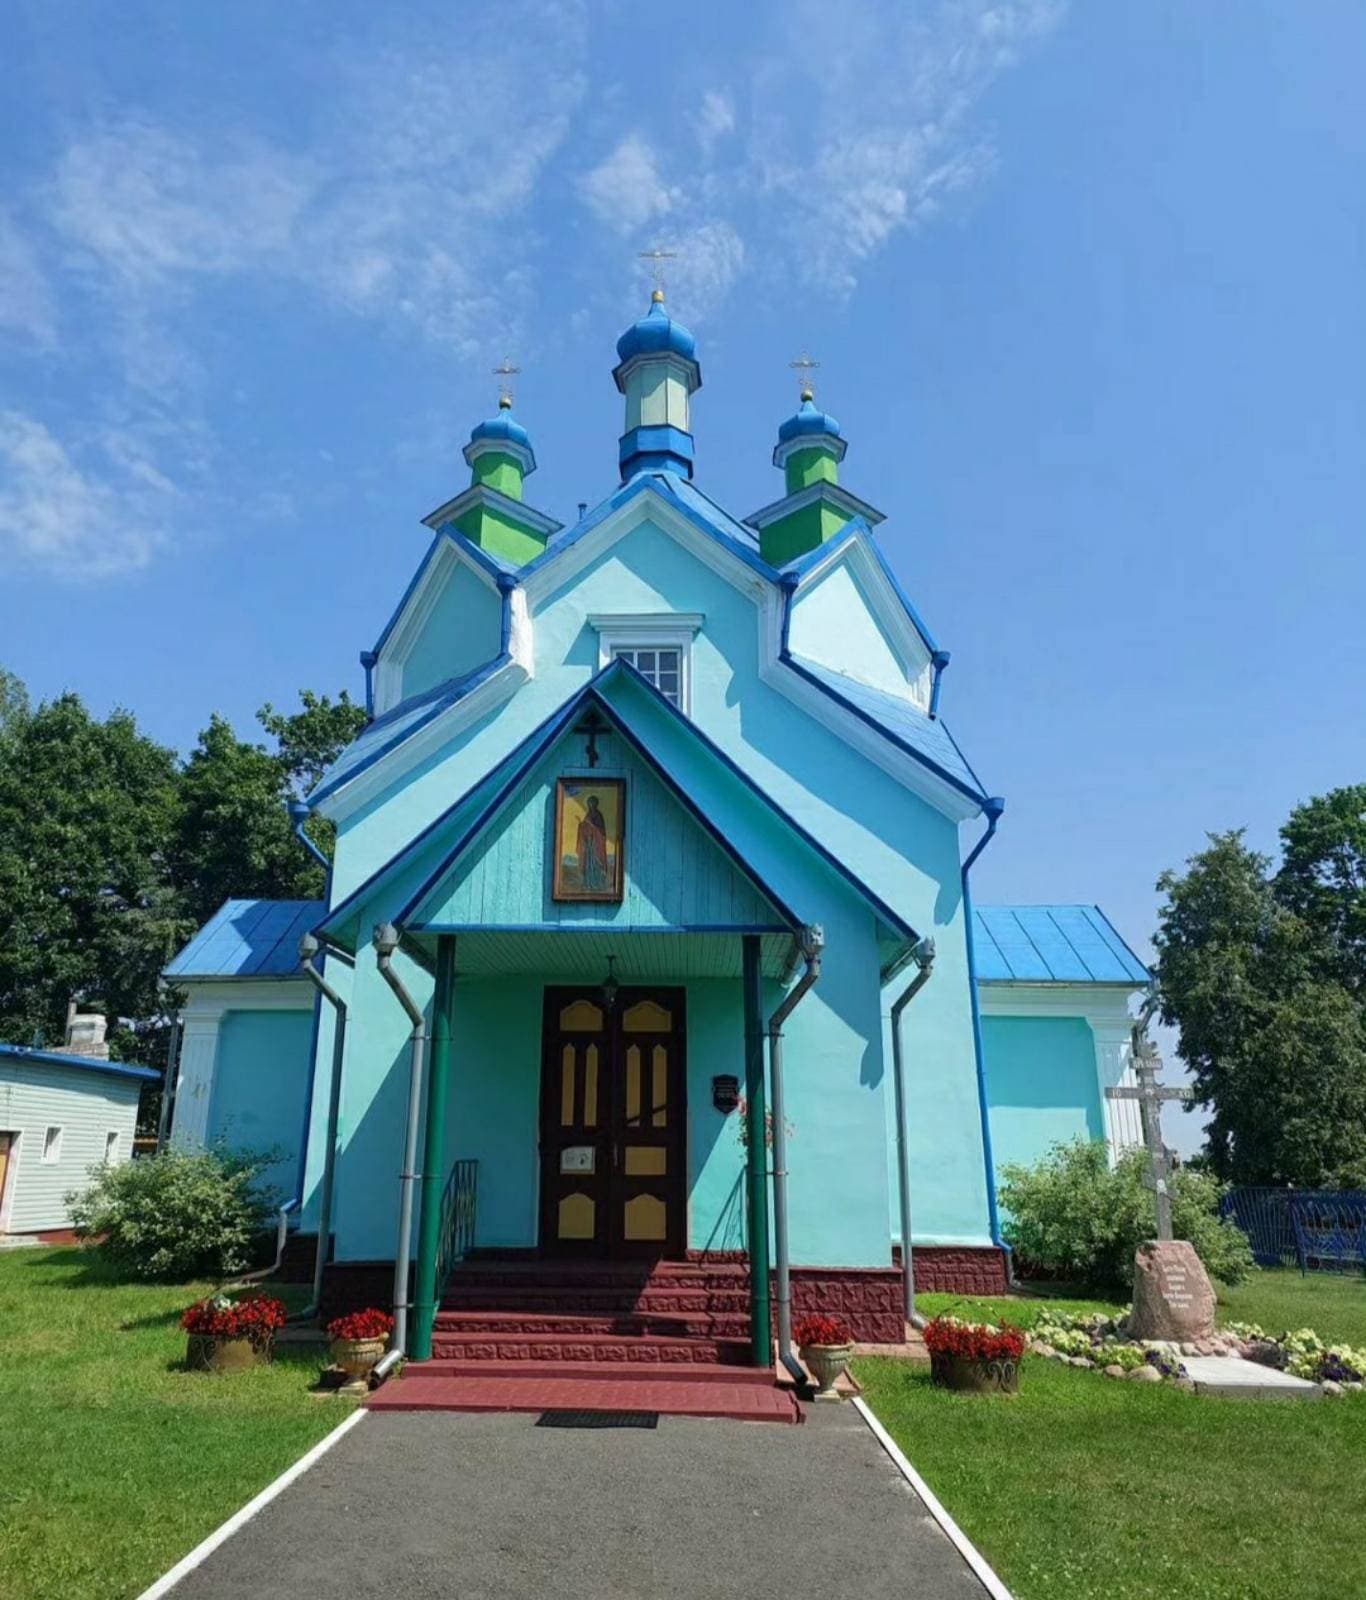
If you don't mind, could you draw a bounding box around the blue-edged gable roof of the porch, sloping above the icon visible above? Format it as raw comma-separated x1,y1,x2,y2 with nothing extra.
315,658,917,949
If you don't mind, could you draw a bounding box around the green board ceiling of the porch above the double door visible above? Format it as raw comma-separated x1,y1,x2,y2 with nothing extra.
401,926,793,984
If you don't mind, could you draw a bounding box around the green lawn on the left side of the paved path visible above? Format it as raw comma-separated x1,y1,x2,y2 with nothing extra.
0,1248,349,1600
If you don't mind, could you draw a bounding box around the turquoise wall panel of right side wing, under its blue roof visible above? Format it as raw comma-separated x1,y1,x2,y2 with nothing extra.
982,1016,1105,1173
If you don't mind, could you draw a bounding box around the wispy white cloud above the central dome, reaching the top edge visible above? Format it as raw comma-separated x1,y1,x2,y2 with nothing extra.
582,0,1064,307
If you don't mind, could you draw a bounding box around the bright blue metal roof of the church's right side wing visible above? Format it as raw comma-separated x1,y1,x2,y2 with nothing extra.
973,906,1148,987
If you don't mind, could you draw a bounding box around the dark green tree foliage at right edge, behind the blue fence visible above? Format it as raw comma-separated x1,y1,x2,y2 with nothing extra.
1155,786,1366,1187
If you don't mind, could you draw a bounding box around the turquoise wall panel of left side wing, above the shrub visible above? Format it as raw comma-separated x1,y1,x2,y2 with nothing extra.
206,1011,314,1197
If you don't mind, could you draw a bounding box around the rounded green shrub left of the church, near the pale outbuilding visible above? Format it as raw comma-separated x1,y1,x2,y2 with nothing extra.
67,1149,277,1278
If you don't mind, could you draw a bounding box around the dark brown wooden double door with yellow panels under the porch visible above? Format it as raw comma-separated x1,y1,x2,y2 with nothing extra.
541,987,688,1259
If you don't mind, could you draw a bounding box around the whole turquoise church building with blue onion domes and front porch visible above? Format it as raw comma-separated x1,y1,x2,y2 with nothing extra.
166,291,1147,1365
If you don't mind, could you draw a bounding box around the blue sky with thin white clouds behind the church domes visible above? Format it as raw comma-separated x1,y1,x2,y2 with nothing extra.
0,0,1366,1145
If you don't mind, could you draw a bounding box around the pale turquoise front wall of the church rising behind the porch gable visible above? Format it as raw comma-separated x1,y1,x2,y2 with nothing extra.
310,496,989,1266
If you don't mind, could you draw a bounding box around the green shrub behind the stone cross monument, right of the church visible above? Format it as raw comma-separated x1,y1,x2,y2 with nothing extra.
1000,1139,1252,1286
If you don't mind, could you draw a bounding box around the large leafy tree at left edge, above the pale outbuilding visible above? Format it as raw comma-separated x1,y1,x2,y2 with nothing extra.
0,675,192,1054
